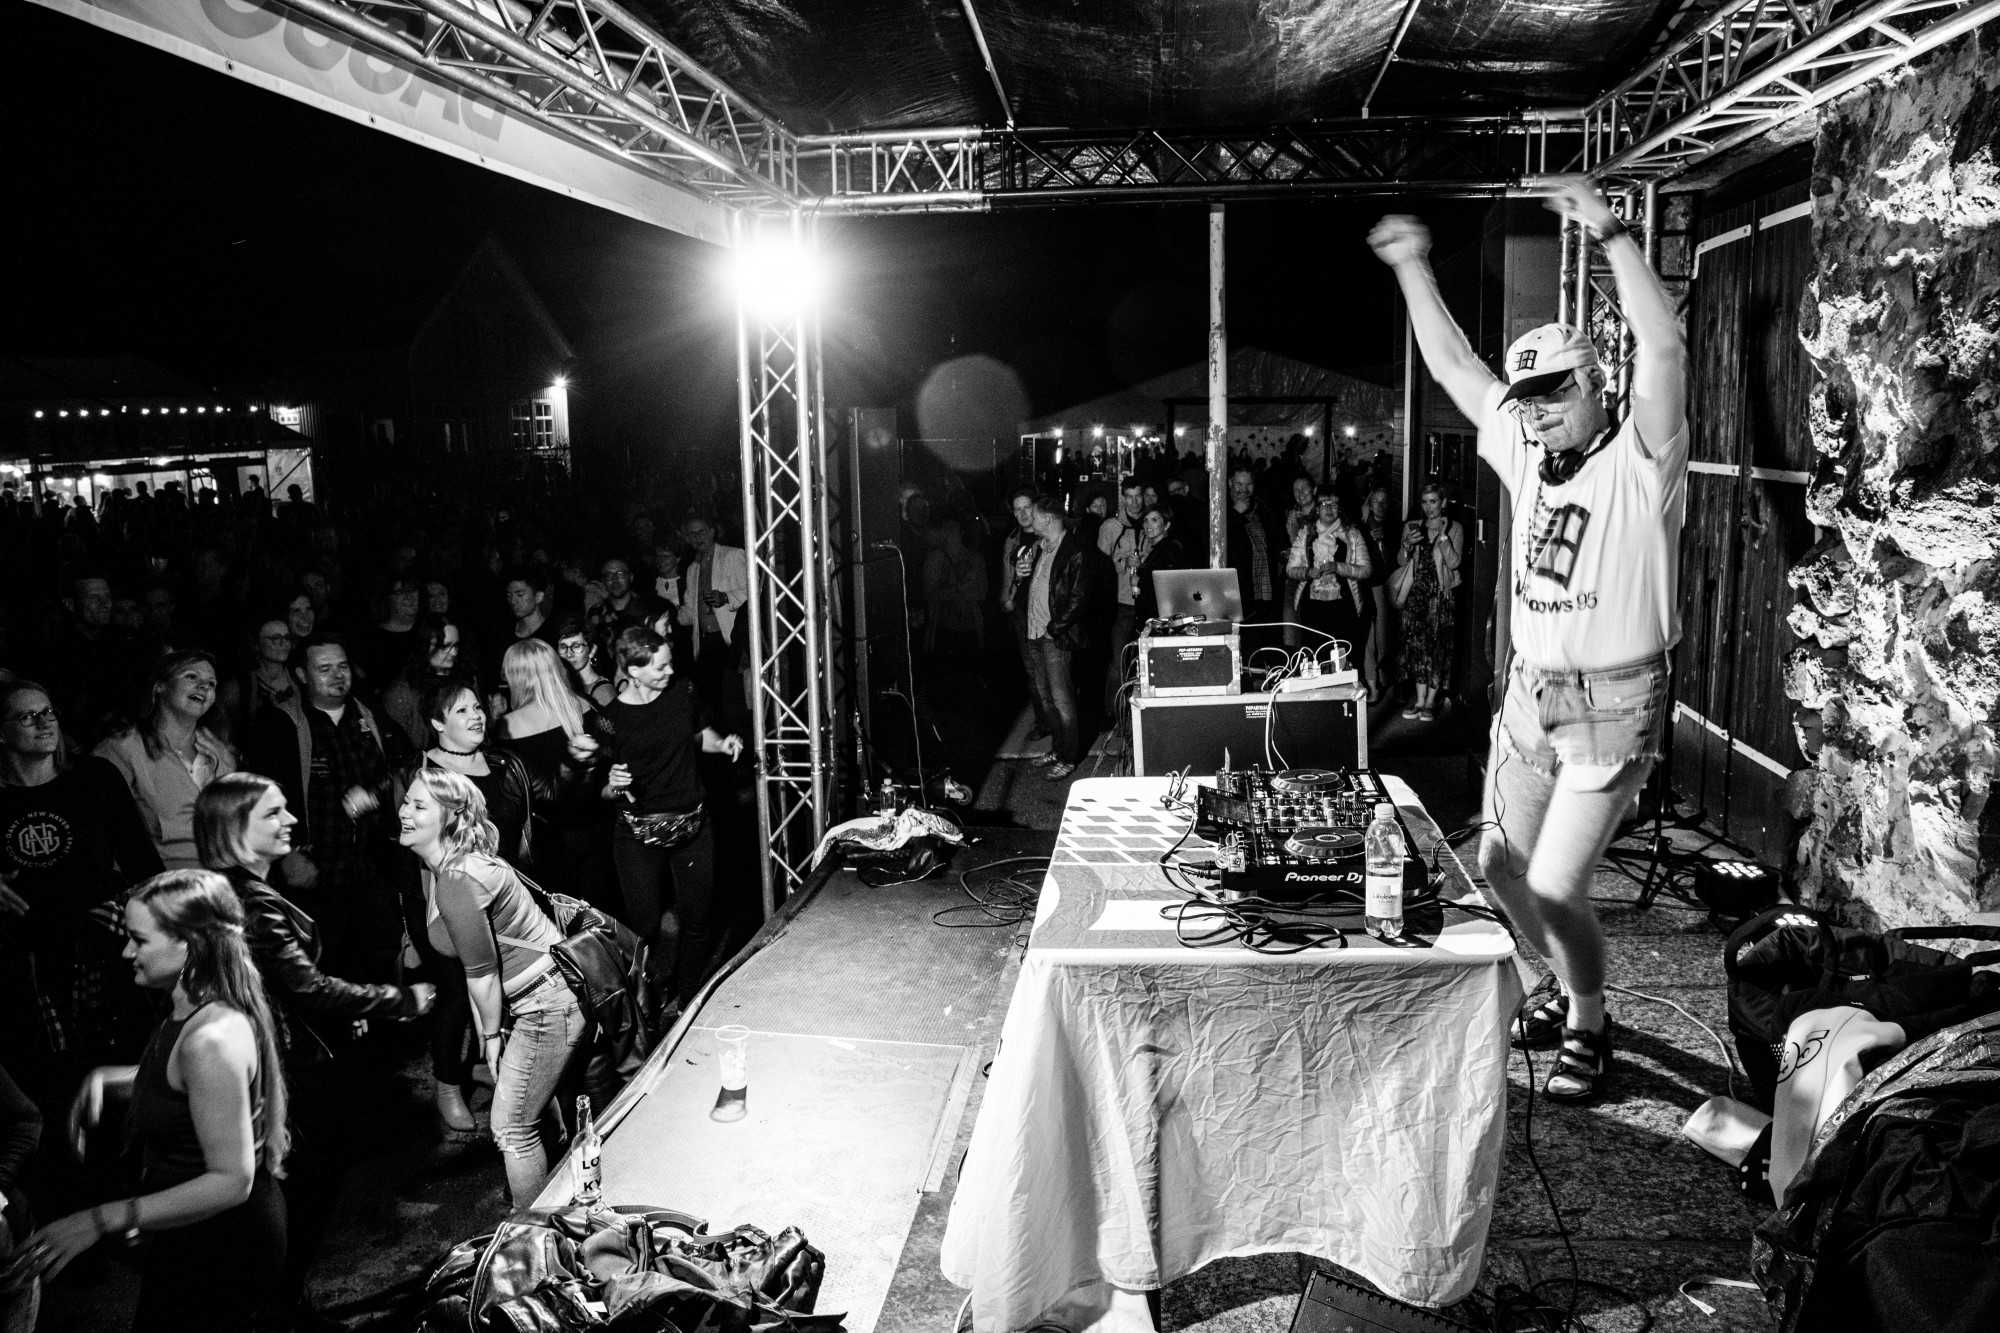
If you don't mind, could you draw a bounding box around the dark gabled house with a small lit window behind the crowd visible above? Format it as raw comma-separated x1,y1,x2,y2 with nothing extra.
406,236,576,480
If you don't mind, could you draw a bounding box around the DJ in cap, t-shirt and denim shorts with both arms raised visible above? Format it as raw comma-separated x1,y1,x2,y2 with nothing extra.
1368,178,1688,1101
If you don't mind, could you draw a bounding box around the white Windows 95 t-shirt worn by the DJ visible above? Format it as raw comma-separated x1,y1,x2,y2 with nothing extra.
1480,382,1688,671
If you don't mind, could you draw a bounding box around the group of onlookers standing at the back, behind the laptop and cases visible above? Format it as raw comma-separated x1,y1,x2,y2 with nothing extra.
898,440,1468,779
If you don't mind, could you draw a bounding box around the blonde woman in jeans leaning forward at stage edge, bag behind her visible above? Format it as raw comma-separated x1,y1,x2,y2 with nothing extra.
398,769,586,1209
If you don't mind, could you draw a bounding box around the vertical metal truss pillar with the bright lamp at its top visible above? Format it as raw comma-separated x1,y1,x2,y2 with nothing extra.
734,210,832,915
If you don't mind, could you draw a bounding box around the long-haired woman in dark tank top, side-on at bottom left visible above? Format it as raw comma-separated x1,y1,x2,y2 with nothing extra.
22,871,288,1333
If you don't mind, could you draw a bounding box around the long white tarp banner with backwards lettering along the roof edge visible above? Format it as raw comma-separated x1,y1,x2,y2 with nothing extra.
36,0,728,244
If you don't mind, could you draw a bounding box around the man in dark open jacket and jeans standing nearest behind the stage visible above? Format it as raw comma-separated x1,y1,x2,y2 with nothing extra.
1016,494,1102,779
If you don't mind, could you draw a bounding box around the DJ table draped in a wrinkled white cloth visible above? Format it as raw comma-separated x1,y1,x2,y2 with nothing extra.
942,779,1520,1333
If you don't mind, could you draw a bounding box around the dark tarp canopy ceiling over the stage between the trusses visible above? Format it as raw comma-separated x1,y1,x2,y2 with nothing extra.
626,0,1688,134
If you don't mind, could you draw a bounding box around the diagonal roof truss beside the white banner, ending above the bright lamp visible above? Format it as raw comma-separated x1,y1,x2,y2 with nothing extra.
276,0,798,208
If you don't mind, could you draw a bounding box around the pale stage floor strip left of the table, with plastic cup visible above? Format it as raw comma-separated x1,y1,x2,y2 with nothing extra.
542,829,1054,1333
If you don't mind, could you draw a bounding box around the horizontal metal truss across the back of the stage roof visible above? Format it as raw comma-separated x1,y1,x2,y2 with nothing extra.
798,110,1584,212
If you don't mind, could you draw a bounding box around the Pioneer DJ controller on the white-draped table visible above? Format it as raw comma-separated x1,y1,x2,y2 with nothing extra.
1194,767,1424,903
